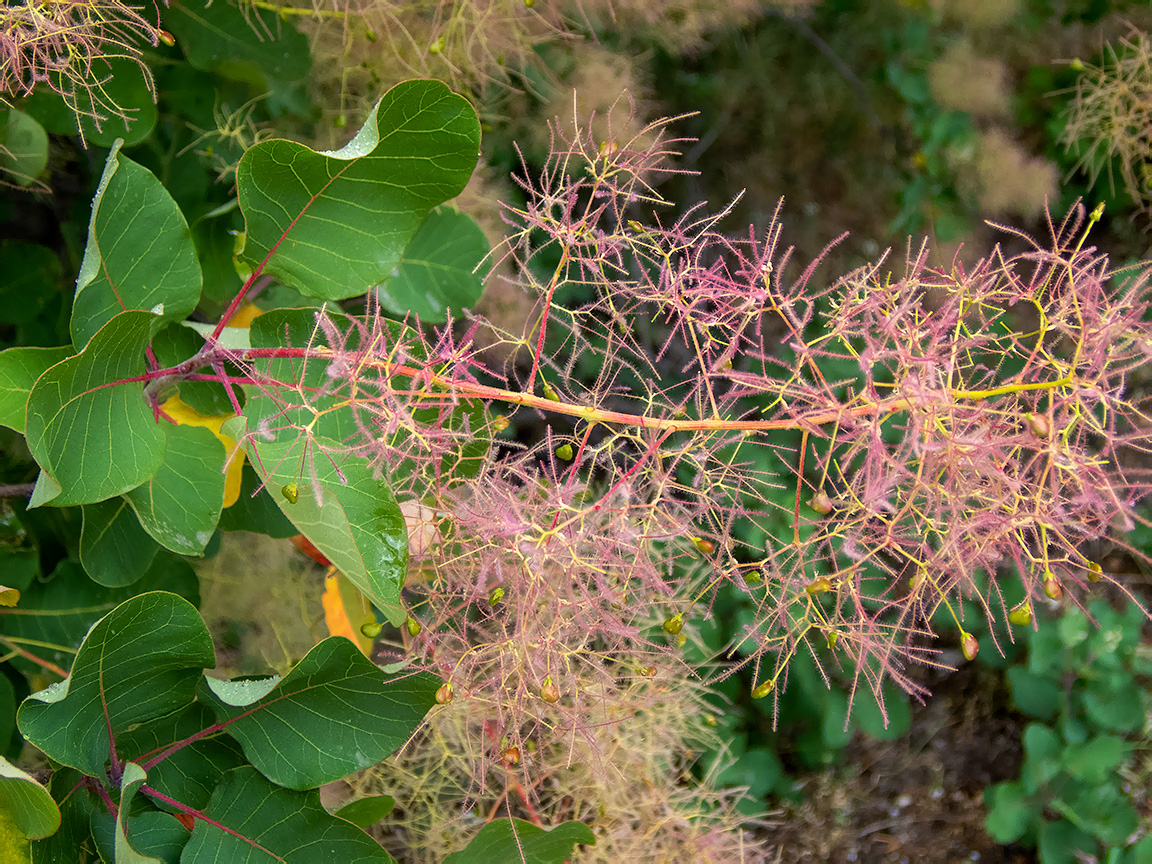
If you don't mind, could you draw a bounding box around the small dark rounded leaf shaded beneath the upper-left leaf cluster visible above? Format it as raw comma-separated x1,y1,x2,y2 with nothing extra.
79,498,157,588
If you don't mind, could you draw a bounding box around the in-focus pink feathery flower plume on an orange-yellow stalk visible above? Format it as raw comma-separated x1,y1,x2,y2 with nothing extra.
224,116,1152,812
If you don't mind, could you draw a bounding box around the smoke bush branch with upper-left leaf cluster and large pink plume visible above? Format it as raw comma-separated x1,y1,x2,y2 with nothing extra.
0,72,1152,859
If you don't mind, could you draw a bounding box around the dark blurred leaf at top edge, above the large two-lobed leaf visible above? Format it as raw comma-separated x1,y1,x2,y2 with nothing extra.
164,0,310,84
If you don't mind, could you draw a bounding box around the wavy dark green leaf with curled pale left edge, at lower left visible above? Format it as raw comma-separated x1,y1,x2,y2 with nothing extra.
16,591,215,776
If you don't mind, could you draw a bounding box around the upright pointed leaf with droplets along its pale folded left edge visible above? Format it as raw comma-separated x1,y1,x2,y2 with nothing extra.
70,143,202,348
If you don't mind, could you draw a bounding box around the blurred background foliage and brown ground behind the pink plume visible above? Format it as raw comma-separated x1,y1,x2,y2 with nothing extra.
0,0,1152,864
